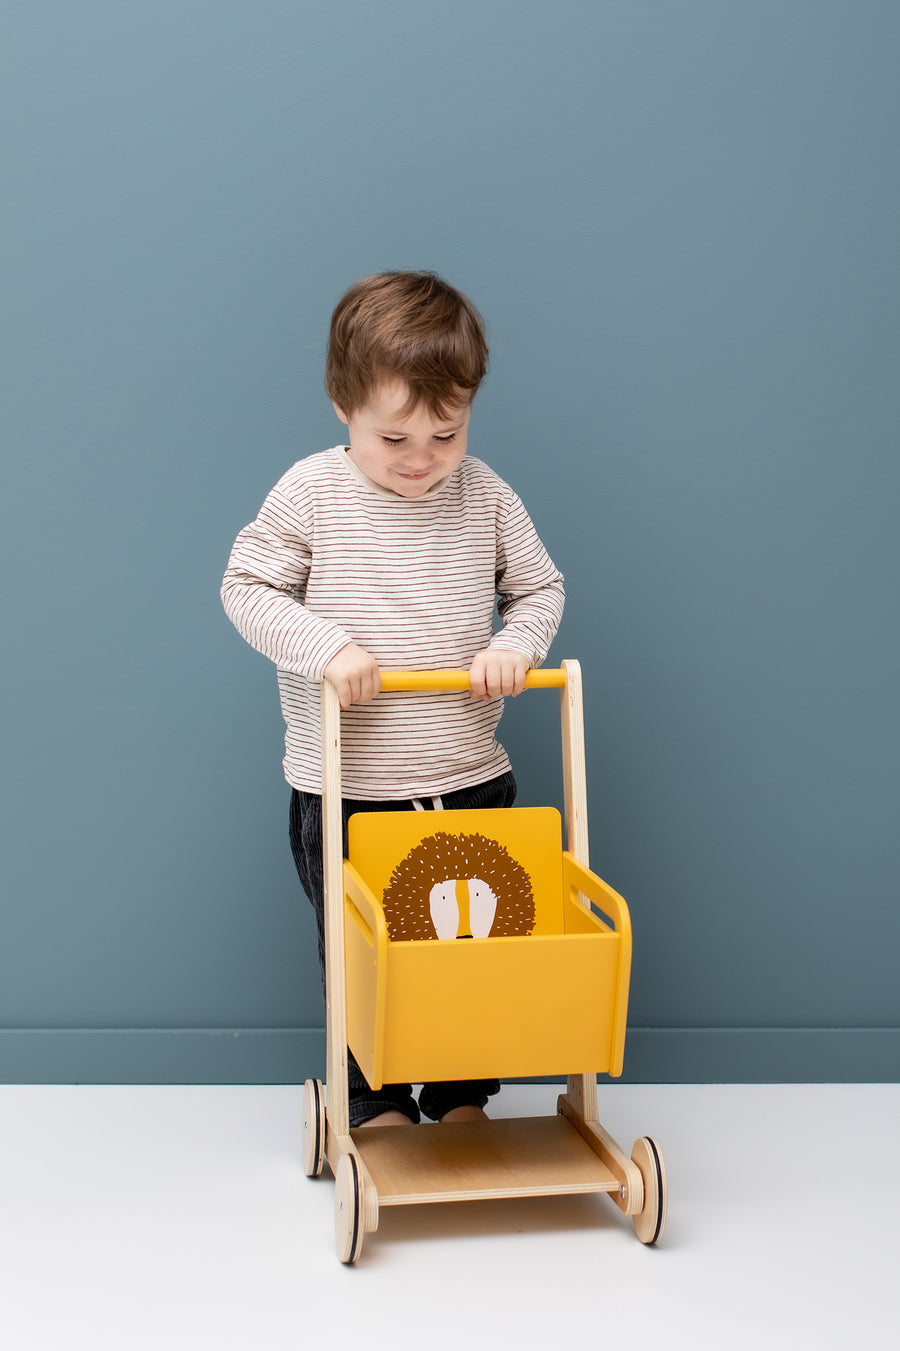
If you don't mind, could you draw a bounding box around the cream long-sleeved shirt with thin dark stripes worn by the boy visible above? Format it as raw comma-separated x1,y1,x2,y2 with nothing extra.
222,446,564,801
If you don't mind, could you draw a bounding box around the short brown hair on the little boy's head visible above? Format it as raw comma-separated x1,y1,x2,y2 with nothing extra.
326,272,488,417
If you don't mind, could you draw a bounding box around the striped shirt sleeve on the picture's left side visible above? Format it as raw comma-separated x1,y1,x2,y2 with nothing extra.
222,484,350,680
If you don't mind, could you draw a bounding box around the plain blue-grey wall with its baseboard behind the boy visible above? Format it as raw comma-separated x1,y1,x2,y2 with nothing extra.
0,0,900,1079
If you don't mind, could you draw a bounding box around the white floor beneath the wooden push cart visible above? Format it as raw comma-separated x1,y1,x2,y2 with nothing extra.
0,1085,900,1351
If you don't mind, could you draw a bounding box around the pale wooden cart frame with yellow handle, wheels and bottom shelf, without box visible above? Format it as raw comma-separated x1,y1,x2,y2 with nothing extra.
303,661,666,1263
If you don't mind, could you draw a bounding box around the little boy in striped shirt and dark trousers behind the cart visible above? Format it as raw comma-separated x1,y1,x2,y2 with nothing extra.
222,272,564,1127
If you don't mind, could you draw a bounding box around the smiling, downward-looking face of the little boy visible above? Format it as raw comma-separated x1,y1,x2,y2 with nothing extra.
334,381,472,497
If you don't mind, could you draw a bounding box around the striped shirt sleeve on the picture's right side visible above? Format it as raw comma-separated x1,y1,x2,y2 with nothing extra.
489,489,565,666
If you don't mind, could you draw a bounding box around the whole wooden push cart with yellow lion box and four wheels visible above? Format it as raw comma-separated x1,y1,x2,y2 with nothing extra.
303,661,666,1263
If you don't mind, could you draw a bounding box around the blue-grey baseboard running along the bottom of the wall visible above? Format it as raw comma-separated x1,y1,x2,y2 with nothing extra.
0,1027,900,1084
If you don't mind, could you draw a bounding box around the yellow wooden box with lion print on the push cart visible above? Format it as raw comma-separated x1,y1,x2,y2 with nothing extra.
343,807,631,1089
